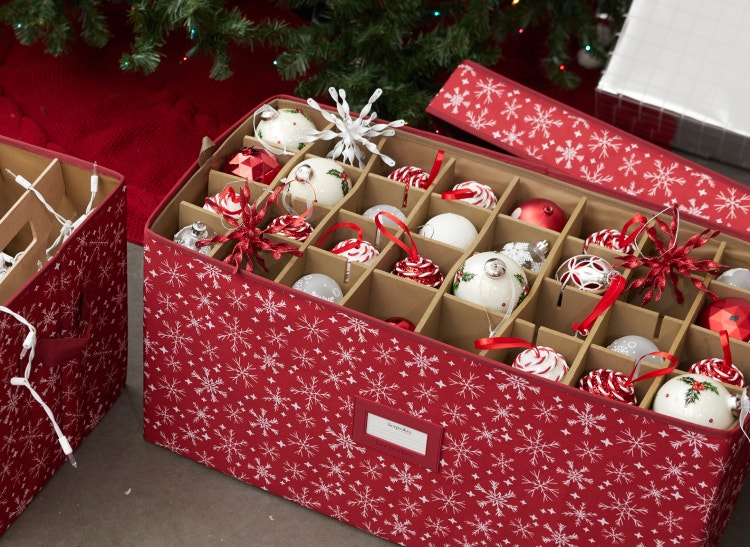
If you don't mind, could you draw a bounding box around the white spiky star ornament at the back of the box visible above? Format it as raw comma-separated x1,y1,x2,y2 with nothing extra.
305,87,406,168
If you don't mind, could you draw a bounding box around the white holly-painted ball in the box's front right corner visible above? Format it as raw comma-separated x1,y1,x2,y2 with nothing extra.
652,373,740,429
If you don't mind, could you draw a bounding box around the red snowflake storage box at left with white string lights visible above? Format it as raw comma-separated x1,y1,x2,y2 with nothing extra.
0,137,127,534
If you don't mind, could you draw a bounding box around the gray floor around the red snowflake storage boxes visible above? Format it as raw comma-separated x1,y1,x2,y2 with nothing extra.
0,152,750,547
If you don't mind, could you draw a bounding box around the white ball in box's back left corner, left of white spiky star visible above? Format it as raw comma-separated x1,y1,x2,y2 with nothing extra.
253,105,317,156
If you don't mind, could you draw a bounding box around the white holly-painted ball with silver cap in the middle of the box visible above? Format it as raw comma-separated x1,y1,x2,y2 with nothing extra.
453,251,529,314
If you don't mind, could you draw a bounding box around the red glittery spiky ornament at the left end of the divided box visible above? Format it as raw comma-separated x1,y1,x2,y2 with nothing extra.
196,180,302,273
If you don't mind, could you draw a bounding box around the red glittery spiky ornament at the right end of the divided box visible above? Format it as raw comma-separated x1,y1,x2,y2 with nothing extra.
616,206,726,306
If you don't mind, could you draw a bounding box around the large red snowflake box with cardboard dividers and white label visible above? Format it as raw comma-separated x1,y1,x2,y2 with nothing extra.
144,97,750,545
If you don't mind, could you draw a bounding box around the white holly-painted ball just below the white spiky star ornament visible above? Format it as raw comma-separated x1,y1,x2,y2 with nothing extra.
285,158,351,207
